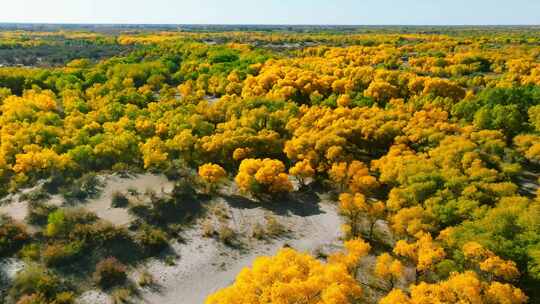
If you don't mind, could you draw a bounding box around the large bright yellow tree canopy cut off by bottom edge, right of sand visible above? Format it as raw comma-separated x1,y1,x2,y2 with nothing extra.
205,249,362,304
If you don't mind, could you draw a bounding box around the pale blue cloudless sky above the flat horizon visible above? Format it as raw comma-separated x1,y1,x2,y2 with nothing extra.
0,0,540,25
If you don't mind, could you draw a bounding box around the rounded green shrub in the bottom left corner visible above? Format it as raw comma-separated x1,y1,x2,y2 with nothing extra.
10,264,67,303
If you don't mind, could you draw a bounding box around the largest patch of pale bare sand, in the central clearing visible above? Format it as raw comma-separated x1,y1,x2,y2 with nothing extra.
142,196,341,304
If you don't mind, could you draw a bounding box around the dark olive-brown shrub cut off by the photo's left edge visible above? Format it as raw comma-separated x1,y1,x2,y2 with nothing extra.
0,218,30,257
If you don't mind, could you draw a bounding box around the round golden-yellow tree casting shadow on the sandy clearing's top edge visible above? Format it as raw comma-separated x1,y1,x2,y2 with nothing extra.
235,158,292,194
